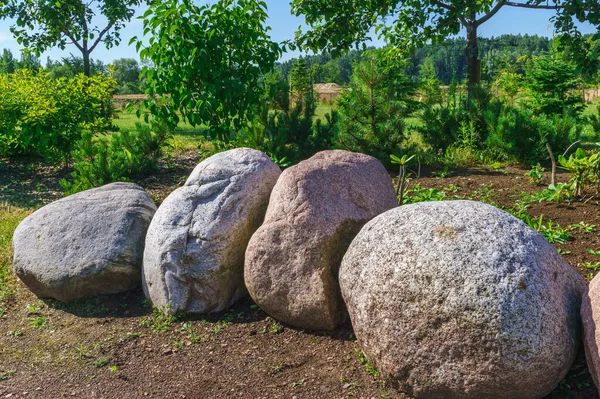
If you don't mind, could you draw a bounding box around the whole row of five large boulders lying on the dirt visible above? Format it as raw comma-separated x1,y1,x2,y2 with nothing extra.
13,148,600,398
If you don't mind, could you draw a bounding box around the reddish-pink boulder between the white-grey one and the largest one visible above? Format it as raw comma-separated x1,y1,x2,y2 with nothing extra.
244,151,398,330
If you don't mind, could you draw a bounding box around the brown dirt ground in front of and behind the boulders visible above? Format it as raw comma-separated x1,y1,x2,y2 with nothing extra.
0,159,600,399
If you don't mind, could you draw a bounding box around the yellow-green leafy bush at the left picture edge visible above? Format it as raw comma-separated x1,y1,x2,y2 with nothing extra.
0,69,114,161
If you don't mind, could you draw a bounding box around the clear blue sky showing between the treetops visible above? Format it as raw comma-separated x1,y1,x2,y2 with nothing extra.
0,0,596,63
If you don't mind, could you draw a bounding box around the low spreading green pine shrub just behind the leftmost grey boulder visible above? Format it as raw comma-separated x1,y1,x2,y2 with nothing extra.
60,123,171,195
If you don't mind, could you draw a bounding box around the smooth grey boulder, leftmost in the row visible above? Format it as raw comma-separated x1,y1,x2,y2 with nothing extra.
13,183,156,302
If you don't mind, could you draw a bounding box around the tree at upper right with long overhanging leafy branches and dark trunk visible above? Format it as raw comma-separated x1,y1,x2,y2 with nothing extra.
292,0,600,90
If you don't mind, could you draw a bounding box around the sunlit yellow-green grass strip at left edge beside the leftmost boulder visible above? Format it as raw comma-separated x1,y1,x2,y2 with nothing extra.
0,203,31,309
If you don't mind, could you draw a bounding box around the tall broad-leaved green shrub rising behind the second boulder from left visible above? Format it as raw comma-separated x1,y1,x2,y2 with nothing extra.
137,0,281,141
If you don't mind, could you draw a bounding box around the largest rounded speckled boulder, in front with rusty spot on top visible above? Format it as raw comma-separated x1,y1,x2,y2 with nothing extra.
339,201,585,399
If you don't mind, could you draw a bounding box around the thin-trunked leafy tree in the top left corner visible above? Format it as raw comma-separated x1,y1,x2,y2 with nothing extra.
0,0,141,76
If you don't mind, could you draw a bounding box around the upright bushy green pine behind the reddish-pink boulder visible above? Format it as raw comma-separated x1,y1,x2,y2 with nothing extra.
338,50,417,166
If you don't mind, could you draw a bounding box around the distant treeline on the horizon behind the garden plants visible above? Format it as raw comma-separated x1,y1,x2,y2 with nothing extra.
0,35,600,90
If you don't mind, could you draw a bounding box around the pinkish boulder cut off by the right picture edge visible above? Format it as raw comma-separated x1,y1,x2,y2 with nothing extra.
581,275,600,393
